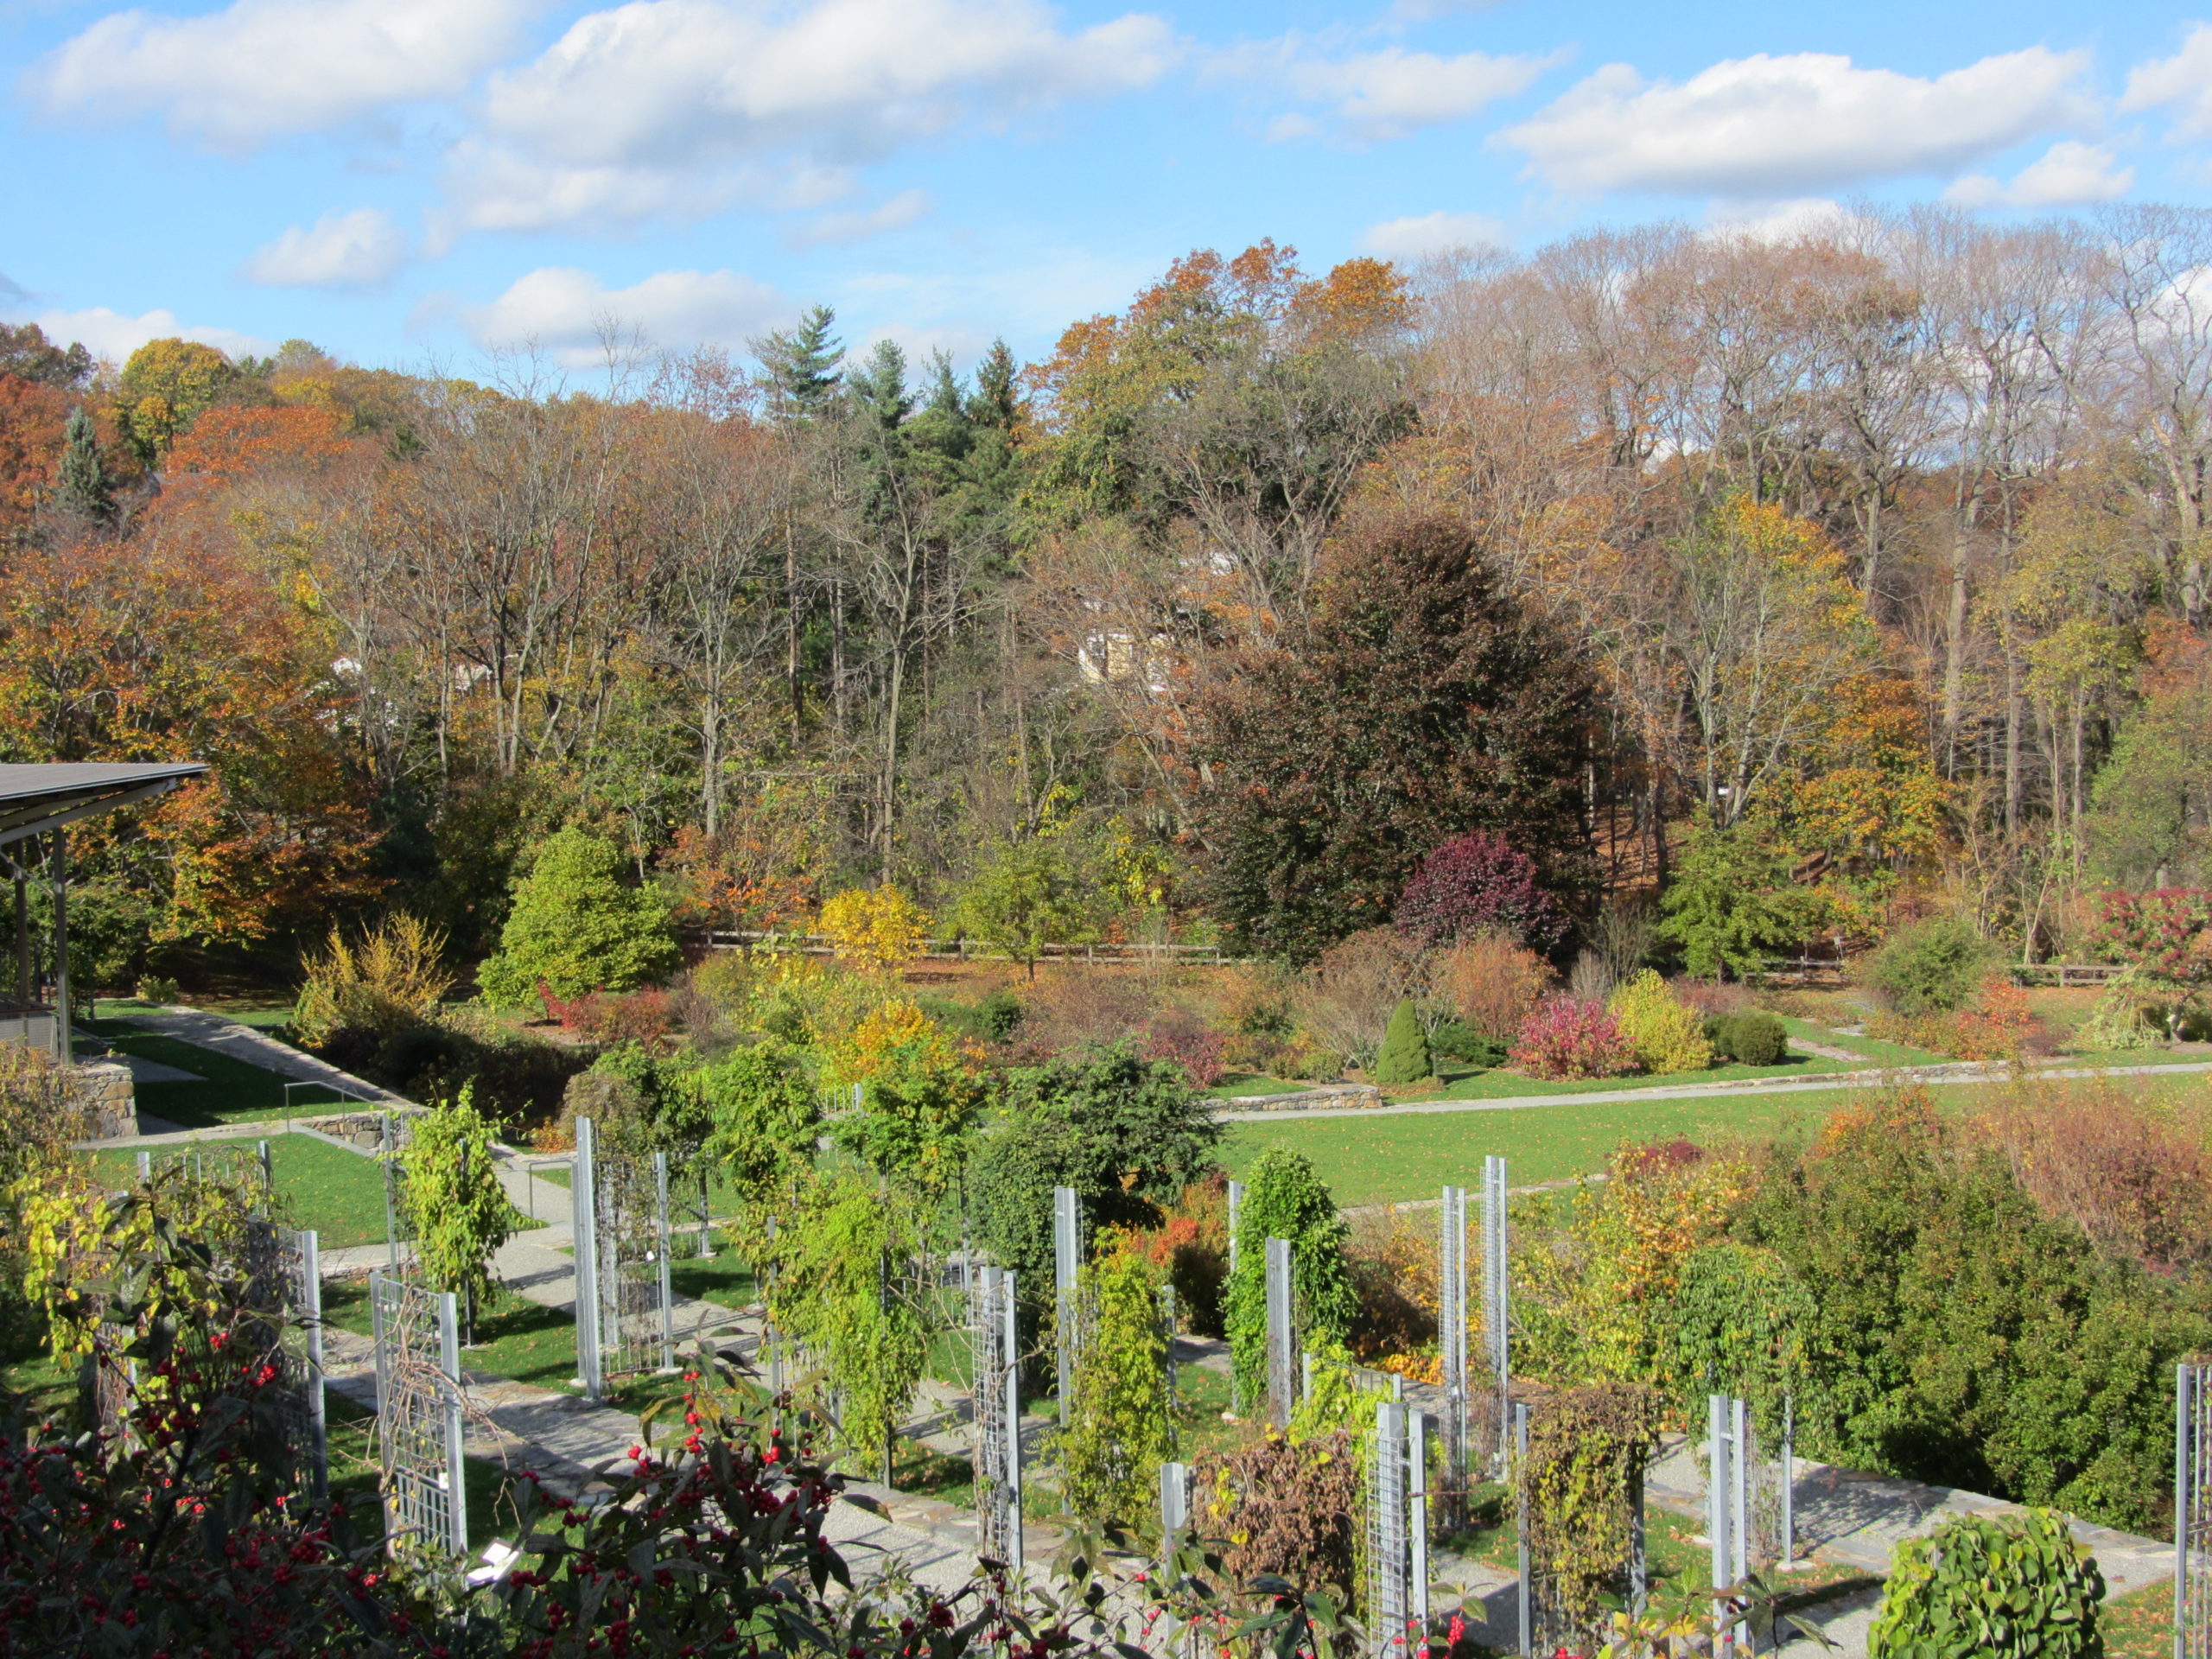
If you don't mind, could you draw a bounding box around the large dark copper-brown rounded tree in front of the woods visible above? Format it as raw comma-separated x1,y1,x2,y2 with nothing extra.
1197,520,1595,960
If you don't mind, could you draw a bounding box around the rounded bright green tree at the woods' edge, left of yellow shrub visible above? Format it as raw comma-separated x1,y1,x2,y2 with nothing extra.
475,825,677,1008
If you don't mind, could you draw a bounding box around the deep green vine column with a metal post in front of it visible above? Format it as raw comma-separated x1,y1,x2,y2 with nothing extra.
1224,1148,1358,1400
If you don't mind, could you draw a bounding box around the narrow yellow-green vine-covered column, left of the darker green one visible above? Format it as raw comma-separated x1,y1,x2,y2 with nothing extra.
1058,1232,1174,1526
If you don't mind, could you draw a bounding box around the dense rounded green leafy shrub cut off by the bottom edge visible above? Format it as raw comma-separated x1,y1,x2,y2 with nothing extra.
1867,1509,2104,1659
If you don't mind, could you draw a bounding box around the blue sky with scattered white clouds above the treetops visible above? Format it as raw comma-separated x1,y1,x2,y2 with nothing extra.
0,0,2212,372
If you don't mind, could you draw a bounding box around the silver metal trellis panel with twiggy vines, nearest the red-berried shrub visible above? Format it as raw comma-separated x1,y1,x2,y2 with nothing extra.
370,1268,469,1555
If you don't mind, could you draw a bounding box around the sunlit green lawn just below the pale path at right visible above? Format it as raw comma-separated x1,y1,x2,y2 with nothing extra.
1221,1073,2205,1205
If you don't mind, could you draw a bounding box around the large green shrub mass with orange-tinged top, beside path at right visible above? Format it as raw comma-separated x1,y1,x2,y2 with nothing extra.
1730,1090,2212,1531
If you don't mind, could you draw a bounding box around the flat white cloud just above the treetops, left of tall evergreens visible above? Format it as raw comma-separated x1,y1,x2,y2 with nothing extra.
460,265,791,367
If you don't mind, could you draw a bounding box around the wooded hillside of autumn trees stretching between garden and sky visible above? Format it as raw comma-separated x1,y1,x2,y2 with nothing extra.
0,208,2212,984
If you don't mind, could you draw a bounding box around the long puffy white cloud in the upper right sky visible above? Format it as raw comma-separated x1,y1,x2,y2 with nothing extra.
1500,47,2094,199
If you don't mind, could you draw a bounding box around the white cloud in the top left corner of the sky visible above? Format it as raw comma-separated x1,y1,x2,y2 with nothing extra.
24,0,533,150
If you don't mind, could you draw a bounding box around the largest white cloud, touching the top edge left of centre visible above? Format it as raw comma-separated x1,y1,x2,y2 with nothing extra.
449,0,1179,228
